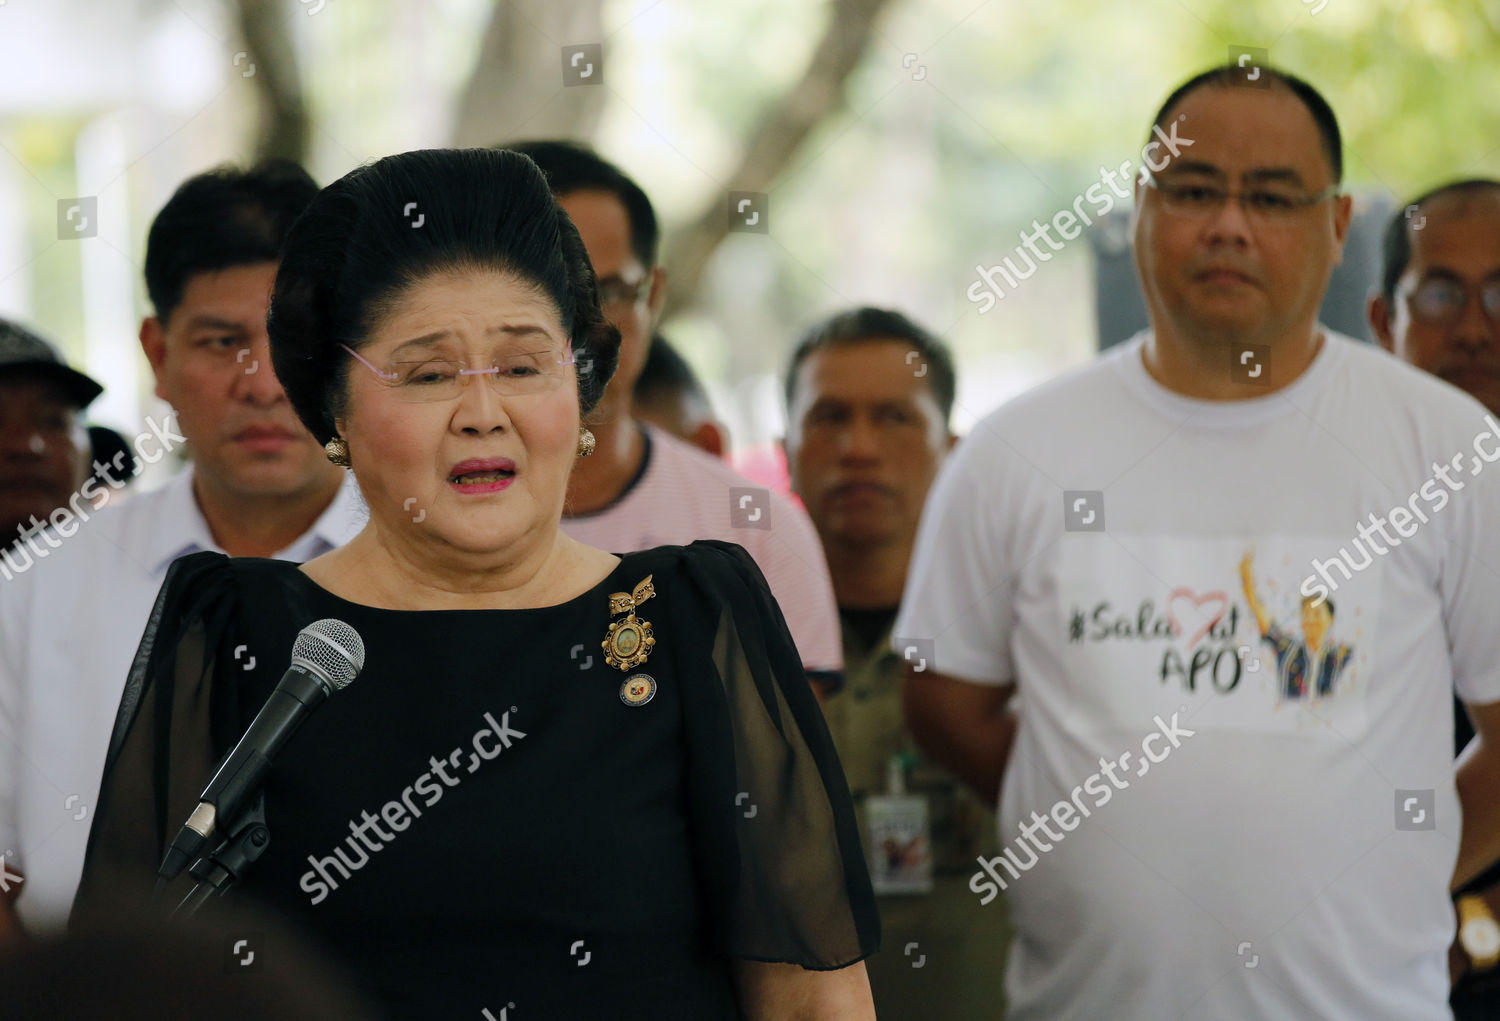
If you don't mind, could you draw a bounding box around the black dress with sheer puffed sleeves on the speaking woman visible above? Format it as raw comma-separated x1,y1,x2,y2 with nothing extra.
74,541,879,1021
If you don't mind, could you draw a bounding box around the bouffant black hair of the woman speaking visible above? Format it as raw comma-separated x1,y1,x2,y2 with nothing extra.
267,148,620,442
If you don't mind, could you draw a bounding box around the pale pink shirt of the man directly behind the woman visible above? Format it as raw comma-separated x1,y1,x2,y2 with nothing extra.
563,426,843,675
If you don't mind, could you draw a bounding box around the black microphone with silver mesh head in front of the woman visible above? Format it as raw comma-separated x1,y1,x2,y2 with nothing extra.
156,618,365,889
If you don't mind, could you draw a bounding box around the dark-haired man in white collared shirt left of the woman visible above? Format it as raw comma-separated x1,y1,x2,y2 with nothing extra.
0,160,365,942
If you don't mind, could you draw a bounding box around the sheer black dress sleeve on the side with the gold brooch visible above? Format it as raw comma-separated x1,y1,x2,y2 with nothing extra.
680,541,881,970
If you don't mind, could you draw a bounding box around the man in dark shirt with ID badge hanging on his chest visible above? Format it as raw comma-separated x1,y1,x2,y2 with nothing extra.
786,307,1010,1021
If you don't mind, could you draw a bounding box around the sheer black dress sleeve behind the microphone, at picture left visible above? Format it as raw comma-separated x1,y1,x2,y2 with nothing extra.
69,552,239,928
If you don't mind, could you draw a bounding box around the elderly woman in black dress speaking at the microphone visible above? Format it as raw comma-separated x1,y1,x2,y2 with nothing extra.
74,150,879,1021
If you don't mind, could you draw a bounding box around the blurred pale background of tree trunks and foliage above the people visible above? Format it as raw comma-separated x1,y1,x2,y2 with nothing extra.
0,0,1500,442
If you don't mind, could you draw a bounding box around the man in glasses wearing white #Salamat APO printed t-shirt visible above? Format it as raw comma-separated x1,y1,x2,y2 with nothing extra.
896,66,1500,1021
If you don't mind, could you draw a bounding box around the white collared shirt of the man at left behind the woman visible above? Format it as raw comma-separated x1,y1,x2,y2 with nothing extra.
0,468,368,930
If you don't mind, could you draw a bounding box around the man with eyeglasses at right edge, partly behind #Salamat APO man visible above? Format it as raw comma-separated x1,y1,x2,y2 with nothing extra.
1367,178,1500,1021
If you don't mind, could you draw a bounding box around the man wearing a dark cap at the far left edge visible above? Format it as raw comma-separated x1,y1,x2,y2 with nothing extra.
0,319,104,557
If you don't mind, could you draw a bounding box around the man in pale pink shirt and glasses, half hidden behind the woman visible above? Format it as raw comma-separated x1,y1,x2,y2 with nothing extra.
509,141,843,683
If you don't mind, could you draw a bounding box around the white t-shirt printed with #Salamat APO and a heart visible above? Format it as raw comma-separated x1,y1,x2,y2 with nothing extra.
894,331,1500,1021
